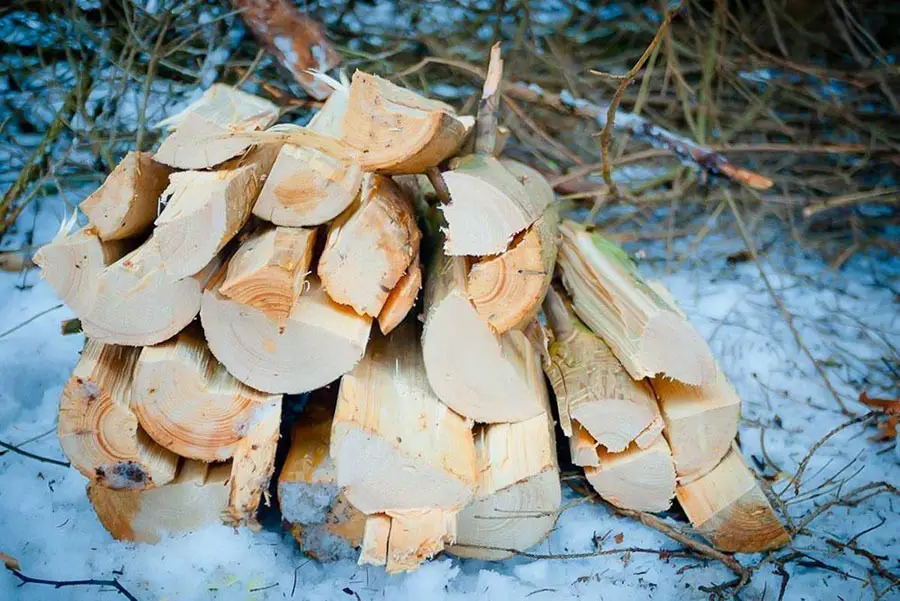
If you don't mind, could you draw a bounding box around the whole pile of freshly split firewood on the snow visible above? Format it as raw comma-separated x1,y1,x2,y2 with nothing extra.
35,49,786,572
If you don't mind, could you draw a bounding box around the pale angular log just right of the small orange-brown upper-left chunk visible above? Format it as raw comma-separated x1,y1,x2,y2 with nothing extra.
153,144,278,280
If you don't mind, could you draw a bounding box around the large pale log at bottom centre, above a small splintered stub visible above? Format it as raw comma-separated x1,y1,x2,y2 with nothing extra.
331,320,475,514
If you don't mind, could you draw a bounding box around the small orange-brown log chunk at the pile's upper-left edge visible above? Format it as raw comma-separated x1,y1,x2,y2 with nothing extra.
79,151,172,240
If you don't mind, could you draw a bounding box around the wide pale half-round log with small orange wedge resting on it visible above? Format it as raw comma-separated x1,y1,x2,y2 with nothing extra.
200,272,372,394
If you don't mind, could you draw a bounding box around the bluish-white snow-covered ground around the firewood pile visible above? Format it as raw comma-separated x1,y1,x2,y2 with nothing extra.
0,198,900,601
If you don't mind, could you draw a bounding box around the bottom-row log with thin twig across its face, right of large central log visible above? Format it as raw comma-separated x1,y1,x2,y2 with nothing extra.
450,390,562,560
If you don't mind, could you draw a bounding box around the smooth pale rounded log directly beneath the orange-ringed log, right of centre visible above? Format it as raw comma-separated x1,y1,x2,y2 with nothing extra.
422,251,544,423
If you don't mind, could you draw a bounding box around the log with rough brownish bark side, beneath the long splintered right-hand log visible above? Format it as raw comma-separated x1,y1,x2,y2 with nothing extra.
544,288,663,450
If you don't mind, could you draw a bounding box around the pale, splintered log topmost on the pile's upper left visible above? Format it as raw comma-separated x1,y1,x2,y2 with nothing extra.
153,84,279,169
